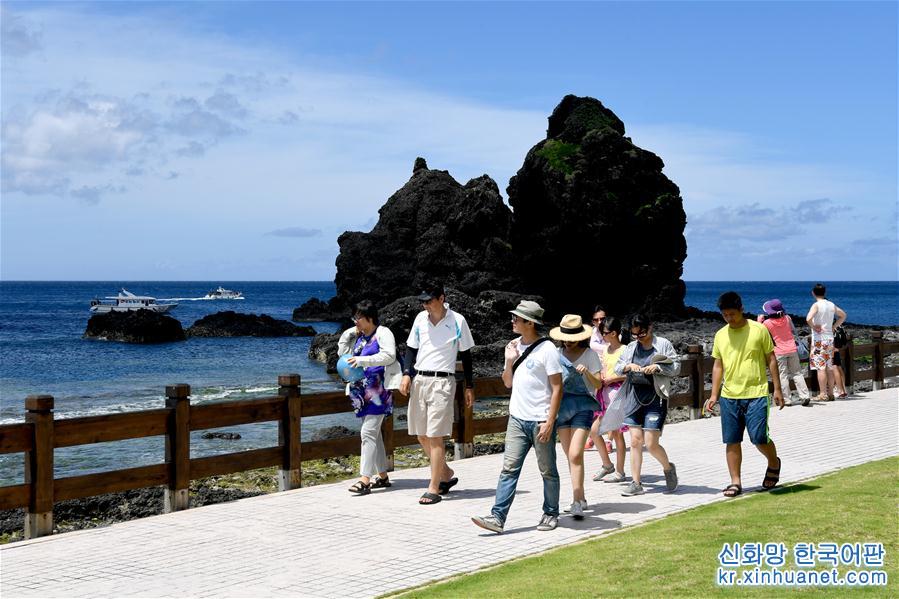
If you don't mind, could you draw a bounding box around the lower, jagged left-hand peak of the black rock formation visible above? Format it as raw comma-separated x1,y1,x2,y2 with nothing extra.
332,158,515,318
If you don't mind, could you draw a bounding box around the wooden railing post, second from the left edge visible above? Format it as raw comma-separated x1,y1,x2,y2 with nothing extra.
163,384,190,513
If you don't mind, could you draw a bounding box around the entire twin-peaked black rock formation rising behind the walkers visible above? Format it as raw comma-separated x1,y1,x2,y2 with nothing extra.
293,96,687,365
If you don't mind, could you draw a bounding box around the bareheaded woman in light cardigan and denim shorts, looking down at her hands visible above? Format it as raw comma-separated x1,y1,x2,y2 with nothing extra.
615,314,678,497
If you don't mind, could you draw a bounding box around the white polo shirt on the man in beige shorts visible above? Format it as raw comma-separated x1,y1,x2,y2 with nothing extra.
406,304,474,372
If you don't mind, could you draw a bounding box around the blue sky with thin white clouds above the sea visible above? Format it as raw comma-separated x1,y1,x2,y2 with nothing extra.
0,2,899,280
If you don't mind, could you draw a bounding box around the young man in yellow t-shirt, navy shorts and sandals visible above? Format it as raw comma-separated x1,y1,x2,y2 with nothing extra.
705,291,784,497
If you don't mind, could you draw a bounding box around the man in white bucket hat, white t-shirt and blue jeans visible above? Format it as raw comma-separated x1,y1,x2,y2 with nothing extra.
471,300,562,533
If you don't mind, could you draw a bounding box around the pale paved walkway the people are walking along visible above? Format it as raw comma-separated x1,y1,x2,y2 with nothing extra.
0,389,899,597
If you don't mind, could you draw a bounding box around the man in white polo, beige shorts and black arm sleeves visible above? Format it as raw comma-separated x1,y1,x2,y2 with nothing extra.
400,284,474,505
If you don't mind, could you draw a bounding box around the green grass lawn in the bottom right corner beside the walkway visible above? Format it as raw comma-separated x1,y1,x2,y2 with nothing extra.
404,458,899,598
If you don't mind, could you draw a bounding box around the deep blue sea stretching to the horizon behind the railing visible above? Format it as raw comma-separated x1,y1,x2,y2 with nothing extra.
0,281,899,484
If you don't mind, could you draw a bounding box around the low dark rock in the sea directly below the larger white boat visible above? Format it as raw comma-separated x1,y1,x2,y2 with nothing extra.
83,310,185,343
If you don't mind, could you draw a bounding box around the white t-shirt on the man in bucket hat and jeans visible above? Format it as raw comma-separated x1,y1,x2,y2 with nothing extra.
509,337,562,422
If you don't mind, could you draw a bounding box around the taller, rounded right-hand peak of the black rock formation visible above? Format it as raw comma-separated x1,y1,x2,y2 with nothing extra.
508,95,687,315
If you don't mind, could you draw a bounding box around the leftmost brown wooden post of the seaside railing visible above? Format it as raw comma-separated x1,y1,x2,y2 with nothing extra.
25,395,53,539
